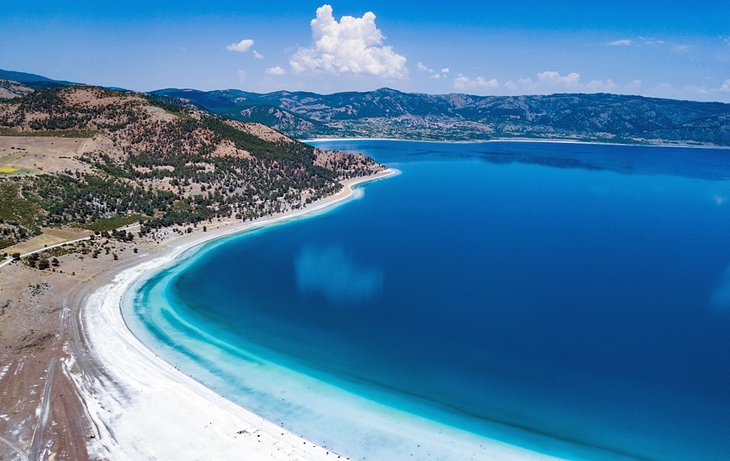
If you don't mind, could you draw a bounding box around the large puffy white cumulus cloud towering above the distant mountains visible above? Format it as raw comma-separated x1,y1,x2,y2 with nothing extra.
289,5,408,78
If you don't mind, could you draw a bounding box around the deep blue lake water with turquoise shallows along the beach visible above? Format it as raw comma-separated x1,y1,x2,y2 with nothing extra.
126,141,730,460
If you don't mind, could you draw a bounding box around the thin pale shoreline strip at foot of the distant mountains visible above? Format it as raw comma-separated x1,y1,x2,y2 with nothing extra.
298,137,730,150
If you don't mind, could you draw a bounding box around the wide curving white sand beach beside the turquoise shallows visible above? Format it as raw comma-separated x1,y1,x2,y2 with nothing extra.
72,169,398,460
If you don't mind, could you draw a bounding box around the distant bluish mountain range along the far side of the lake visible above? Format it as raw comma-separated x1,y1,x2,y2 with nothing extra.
153,88,730,146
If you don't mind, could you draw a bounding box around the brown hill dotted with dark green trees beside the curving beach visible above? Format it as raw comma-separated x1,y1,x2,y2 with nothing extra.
0,83,383,247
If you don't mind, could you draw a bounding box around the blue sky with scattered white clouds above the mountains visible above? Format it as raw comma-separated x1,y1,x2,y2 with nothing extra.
0,0,730,102
